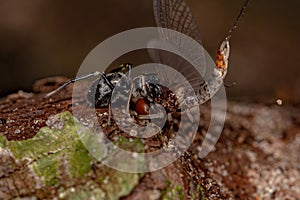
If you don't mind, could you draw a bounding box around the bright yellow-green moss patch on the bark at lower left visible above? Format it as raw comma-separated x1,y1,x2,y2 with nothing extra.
10,112,95,186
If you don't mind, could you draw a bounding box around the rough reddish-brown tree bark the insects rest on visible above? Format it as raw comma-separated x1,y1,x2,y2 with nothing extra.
0,77,300,199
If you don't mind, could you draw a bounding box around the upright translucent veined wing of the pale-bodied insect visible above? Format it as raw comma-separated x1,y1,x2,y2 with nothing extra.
149,0,206,91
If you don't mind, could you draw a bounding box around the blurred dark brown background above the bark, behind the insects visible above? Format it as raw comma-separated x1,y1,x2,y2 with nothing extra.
0,0,300,102
